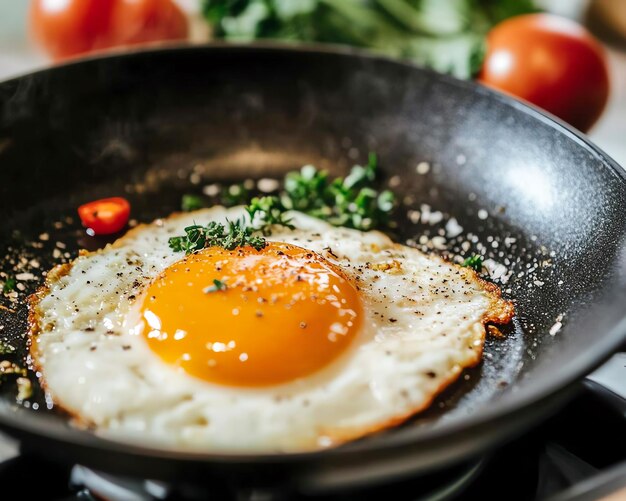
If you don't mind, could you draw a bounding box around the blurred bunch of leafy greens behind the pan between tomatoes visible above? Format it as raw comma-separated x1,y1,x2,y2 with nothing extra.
202,0,539,78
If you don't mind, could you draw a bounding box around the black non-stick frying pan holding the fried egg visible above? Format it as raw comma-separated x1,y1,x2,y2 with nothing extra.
0,45,626,496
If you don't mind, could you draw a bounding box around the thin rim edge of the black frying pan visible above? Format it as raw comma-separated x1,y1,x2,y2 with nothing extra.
0,42,626,464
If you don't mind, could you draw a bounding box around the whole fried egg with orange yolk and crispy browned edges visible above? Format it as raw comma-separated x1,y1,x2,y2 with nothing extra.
30,207,513,452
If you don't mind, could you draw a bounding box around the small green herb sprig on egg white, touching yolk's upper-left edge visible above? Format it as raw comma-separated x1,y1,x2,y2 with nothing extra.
169,219,267,254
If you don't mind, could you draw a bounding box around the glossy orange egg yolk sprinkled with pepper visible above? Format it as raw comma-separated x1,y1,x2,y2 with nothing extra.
136,243,362,386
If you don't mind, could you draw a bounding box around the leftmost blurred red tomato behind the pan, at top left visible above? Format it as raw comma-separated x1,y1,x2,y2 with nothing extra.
30,0,115,59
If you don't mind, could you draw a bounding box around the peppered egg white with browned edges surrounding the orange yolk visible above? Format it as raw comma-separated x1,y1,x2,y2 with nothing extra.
31,207,513,452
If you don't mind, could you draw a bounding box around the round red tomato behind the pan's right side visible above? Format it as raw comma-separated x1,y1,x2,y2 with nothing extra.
478,14,609,131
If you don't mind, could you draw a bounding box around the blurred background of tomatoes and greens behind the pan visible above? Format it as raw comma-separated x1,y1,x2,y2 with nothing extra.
0,0,626,165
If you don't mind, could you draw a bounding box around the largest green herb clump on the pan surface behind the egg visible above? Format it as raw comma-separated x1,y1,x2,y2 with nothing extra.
281,153,396,231
